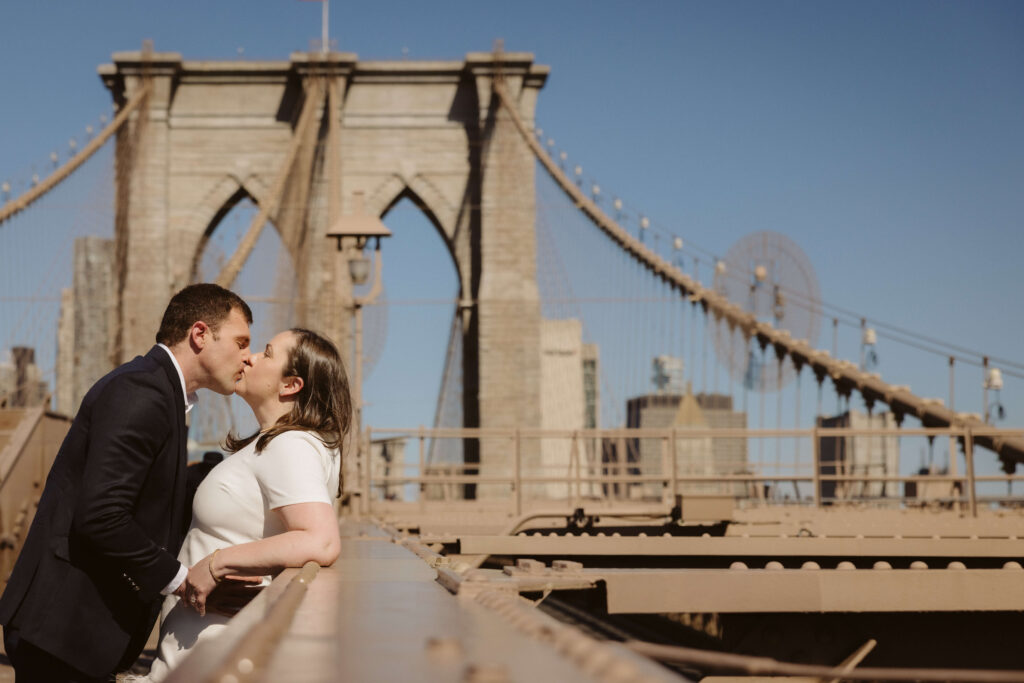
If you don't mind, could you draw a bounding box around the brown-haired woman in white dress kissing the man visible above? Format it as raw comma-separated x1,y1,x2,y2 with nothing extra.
150,328,352,681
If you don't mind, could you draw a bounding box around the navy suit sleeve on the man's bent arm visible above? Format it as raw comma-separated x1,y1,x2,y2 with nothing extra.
73,373,179,600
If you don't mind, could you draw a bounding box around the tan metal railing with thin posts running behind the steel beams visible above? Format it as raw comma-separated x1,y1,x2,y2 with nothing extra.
348,427,1024,516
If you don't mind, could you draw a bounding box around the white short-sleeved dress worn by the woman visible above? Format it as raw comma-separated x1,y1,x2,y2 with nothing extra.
150,431,341,681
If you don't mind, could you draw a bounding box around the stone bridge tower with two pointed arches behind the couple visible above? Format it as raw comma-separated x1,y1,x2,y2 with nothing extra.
78,52,548,489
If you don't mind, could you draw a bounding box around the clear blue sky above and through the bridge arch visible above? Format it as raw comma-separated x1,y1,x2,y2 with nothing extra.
0,0,1024,481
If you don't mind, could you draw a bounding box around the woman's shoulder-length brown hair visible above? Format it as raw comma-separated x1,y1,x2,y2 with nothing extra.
224,328,352,497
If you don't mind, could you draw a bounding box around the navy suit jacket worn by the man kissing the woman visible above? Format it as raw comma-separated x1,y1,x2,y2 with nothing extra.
0,346,187,677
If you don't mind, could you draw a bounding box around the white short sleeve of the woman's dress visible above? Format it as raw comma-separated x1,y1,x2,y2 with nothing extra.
253,431,332,510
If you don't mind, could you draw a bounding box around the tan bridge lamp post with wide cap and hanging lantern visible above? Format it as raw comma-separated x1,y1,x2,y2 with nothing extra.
327,193,391,485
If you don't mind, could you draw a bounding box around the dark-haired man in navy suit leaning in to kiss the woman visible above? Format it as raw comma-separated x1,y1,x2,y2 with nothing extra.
0,285,252,683
